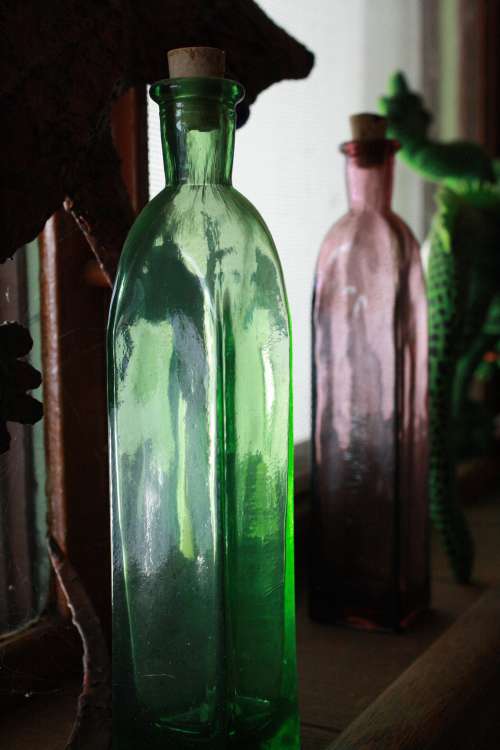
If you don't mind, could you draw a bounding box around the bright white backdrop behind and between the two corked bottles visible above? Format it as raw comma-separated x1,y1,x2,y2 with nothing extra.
149,0,424,442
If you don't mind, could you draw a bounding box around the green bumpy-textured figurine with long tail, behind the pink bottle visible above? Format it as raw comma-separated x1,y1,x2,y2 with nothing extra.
380,73,500,583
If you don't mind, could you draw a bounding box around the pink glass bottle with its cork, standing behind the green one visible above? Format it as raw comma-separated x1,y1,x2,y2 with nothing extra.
310,115,429,630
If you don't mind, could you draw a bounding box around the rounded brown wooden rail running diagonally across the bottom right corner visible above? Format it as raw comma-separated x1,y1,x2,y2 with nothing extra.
329,588,500,750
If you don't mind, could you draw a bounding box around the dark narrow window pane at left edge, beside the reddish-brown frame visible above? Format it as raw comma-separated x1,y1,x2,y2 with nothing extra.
0,242,50,636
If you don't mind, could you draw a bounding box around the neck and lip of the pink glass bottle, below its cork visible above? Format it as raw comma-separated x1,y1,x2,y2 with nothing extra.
341,141,398,211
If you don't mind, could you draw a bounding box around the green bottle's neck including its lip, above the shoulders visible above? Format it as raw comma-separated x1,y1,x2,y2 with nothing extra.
151,78,246,185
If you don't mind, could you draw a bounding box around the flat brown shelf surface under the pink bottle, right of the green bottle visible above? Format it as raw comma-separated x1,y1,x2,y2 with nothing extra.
297,499,500,750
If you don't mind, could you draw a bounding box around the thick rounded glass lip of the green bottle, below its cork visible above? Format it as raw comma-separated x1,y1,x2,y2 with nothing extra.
149,77,245,106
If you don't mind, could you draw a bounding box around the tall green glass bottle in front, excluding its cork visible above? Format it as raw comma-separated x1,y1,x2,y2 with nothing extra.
108,48,299,750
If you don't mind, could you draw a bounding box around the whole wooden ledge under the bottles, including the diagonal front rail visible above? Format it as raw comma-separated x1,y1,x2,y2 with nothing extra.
0,499,500,750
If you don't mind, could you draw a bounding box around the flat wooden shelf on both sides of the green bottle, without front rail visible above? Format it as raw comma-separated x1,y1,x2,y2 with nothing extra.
0,499,500,750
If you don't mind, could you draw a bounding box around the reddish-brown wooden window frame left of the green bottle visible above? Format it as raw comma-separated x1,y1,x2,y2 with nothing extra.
0,87,148,711
